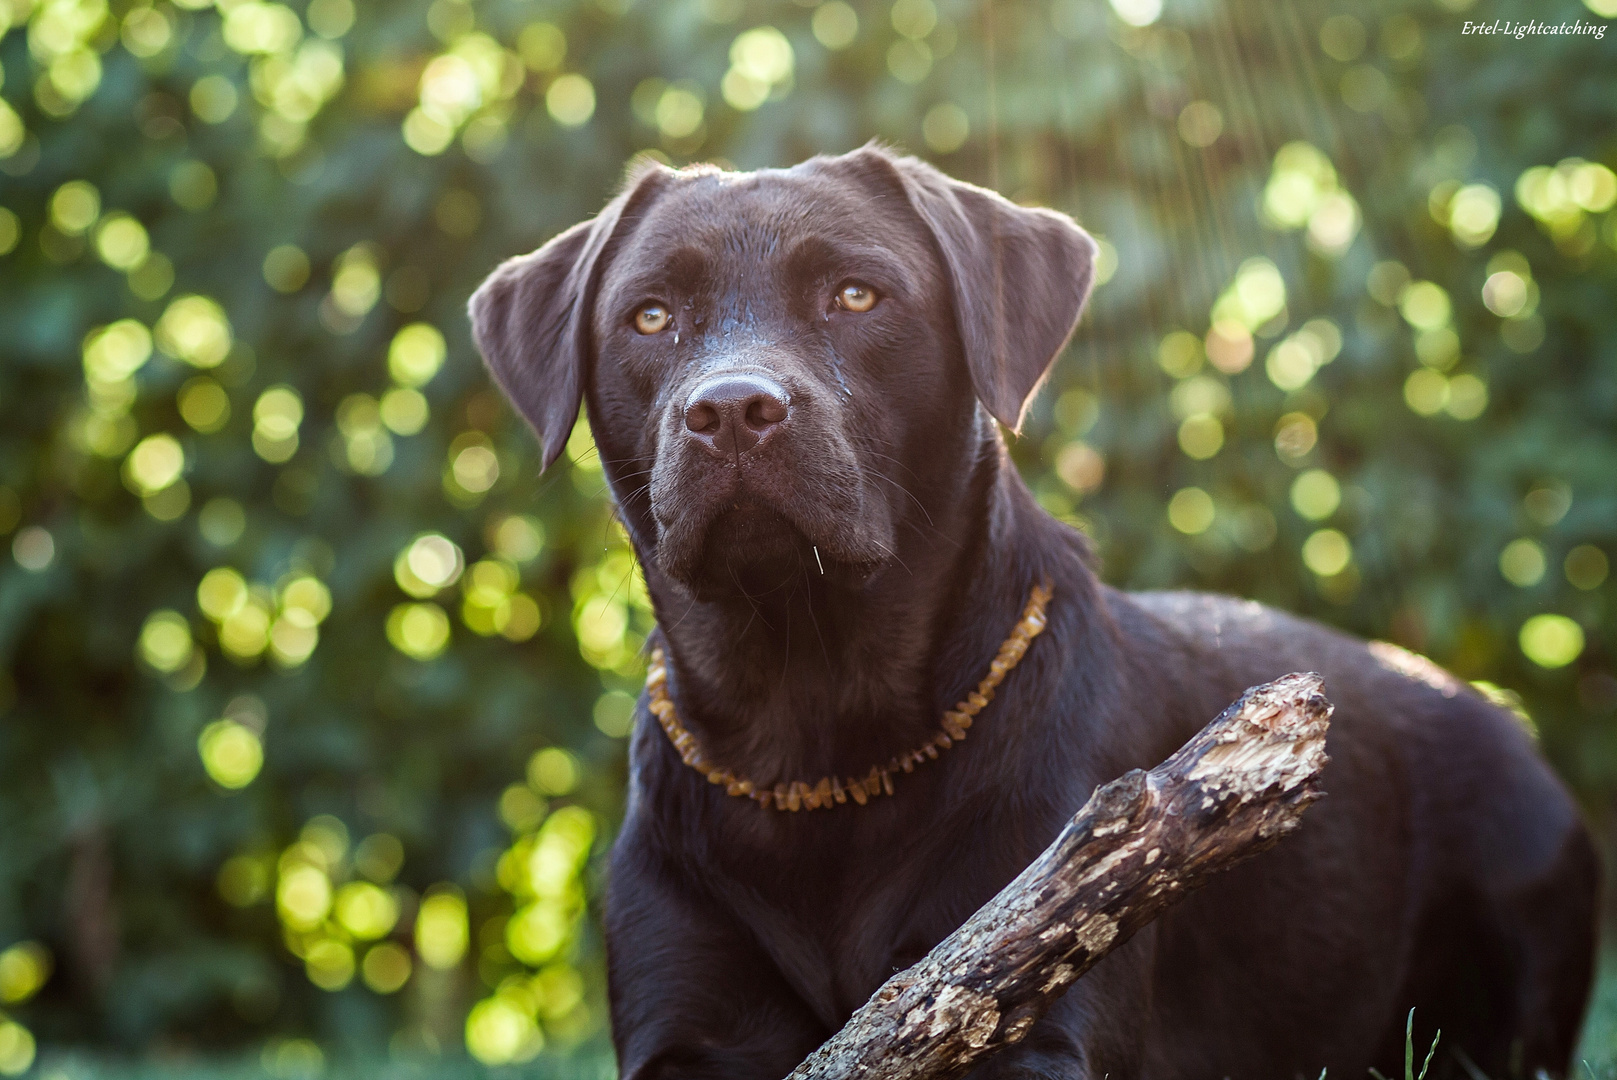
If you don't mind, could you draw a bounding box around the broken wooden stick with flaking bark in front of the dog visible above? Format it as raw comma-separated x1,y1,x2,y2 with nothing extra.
789,674,1332,1080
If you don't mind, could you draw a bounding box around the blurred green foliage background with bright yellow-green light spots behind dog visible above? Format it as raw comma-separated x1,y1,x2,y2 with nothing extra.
0,0,1617,1080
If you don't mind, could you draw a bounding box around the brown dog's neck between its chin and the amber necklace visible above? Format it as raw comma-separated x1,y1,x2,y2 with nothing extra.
624,433,1041,783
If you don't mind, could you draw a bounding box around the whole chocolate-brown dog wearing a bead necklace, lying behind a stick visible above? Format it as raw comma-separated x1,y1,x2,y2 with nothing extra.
471,146,1599,1080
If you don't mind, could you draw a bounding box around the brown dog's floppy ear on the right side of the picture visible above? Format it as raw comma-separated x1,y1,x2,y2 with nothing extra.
851,147,1096,432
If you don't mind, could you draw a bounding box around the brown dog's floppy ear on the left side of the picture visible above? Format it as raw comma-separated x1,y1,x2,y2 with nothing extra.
469,165,671,469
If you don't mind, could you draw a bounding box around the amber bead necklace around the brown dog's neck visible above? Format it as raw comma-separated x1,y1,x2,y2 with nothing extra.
645,580,1053,810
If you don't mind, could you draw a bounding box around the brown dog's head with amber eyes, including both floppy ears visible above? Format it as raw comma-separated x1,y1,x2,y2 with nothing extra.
471,147,1095,595
